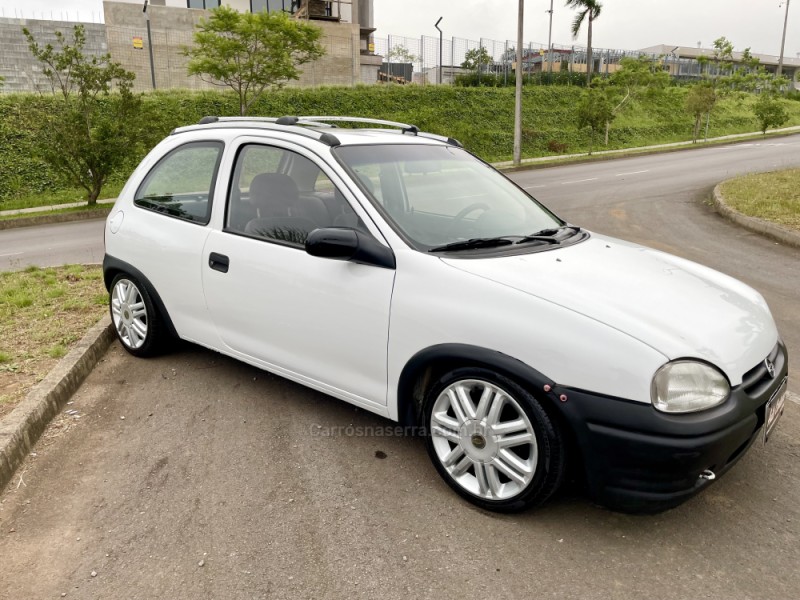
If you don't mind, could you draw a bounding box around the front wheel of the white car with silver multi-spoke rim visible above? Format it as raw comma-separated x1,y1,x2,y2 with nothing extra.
424,367,567,512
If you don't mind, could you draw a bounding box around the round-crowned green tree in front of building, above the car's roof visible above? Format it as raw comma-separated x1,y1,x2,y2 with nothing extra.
184,6,325,115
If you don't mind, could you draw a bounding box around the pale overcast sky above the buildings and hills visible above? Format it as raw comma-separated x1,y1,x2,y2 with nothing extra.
0,0,800,58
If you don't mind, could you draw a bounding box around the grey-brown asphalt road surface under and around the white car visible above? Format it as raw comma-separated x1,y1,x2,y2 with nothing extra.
0,136,800,600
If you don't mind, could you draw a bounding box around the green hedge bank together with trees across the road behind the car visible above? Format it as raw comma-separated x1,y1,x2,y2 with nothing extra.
0,14,800,210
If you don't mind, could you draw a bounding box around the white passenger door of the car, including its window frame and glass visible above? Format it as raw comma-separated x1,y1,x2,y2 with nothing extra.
203,142,395,412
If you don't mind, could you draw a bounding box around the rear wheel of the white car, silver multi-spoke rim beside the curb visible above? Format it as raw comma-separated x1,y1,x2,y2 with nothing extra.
109,273,166,357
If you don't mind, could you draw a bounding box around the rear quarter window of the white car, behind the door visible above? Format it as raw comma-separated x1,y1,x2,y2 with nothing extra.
133,142,223,225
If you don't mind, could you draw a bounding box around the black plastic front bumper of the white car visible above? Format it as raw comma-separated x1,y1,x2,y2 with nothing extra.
554,342,788,512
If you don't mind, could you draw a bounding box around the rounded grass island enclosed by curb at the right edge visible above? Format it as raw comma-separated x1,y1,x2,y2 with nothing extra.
721,169,800,231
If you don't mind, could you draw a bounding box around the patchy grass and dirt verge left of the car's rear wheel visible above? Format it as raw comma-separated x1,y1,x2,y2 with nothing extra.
0,265,107,416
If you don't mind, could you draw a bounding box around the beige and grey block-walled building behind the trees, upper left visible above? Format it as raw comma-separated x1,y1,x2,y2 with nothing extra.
0,0,382,92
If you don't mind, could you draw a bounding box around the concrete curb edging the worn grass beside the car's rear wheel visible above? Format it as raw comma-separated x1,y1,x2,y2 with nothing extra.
0,315,114,490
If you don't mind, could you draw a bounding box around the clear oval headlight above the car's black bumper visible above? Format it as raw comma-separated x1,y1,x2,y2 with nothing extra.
651,360,731,413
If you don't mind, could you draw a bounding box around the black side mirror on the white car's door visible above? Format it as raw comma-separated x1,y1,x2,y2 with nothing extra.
306,227,396,269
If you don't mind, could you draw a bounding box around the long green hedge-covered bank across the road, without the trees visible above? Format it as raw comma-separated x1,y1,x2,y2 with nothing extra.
0,83,800,209
